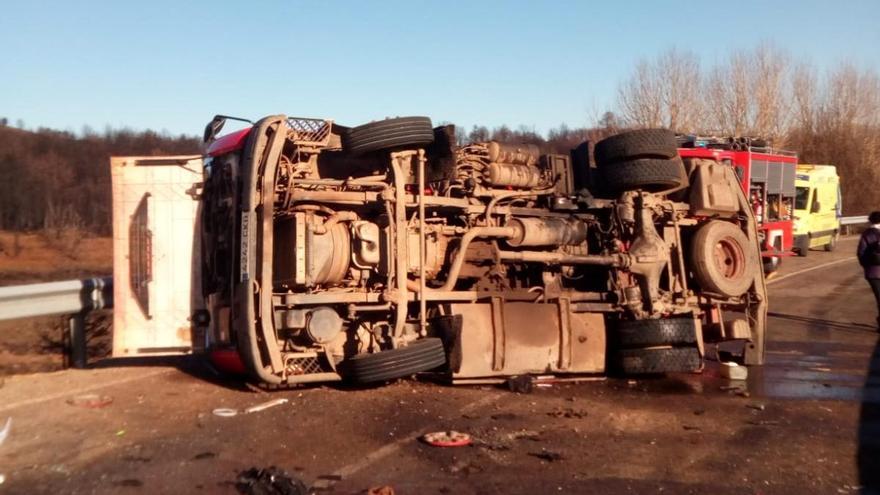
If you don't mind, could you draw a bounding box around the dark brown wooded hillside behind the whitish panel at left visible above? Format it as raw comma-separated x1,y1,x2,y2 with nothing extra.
0,123,200,235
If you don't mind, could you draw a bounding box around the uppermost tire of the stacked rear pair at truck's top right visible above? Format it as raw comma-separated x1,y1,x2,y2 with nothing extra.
593,129,678,166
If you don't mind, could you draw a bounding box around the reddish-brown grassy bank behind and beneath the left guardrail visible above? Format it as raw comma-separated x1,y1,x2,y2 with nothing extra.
0,230,113,375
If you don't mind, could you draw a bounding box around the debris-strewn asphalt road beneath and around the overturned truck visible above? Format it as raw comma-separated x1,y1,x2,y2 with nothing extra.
0,239,880,494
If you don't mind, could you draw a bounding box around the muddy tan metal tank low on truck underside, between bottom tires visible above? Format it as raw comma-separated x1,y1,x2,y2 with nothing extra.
452,300,605,379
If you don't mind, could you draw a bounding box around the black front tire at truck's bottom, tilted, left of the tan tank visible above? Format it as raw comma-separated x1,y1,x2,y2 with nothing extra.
340,338,446,383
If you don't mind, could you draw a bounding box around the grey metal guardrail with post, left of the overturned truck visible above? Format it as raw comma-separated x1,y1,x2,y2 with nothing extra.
0,277,113,368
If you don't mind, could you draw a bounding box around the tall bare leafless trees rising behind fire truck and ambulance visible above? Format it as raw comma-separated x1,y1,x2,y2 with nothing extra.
617,44,880,215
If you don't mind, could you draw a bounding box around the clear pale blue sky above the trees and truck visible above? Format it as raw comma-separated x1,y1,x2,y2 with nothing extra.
0,0,880,134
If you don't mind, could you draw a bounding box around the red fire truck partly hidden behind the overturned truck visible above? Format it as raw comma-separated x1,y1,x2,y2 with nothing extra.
679,135,797,273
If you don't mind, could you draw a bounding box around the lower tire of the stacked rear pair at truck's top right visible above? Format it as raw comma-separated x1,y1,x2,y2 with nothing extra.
599,158,688,193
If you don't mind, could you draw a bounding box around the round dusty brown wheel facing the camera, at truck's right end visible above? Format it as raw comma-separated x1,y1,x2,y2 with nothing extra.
691,220,760,297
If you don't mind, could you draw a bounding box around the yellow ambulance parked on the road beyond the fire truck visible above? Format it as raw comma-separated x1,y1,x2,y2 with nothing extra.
794,164,842,256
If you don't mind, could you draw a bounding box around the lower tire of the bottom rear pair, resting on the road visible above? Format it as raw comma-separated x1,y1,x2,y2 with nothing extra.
609,347,703,375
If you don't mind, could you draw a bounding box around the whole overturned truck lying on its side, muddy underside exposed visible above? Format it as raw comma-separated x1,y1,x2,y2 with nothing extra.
112,115,767,386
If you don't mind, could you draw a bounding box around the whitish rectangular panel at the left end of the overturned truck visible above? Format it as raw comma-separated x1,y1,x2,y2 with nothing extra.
110,156,203,357
